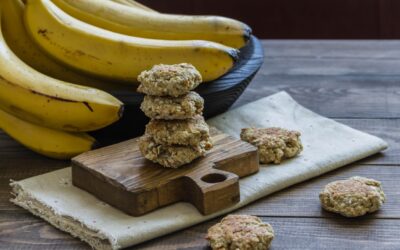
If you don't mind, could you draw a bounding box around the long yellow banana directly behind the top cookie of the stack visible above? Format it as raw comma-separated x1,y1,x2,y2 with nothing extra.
25,0,238,83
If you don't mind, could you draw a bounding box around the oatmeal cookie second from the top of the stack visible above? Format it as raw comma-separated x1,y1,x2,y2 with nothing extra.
140,91,204,120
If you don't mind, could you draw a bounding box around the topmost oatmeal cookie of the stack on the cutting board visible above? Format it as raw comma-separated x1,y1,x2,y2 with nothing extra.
137,63,202,97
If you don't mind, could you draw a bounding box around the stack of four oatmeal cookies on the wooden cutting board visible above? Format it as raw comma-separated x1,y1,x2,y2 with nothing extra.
138,63,212,168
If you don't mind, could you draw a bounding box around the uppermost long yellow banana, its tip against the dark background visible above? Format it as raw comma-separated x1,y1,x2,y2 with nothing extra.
52,0,251,48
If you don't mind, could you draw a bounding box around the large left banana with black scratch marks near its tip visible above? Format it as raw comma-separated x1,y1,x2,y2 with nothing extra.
0,7,123,131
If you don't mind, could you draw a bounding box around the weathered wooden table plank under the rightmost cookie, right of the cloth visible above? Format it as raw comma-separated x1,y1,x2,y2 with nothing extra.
239,164,400,219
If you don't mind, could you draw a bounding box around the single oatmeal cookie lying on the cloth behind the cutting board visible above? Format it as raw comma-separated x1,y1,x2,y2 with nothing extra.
240,128,303,164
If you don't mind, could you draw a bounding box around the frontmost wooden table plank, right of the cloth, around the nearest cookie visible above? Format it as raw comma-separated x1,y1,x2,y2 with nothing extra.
132,217,400,250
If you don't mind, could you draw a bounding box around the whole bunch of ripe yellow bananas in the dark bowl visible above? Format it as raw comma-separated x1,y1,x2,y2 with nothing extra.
0,0,251,159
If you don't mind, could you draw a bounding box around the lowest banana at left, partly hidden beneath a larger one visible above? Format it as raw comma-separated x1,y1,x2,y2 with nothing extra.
0,109,96,159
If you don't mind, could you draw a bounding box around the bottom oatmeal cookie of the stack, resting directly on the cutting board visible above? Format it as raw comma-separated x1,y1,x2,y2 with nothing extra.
139,135,206,168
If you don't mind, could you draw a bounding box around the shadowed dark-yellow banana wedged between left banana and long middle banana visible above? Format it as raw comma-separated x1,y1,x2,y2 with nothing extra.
0,0,127,91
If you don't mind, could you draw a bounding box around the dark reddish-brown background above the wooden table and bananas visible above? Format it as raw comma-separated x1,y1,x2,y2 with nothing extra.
139,0,400,39
